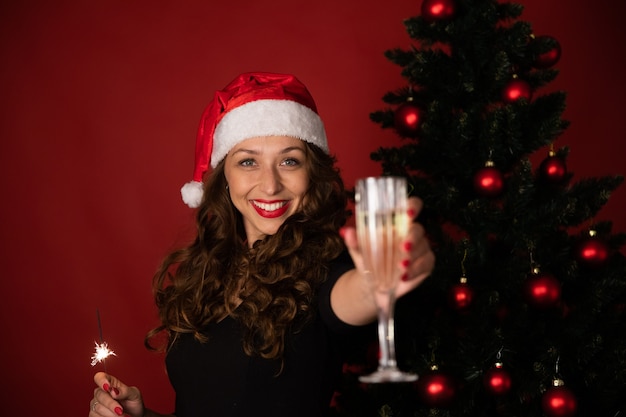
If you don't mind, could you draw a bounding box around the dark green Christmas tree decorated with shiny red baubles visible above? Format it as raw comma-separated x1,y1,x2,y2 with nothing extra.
336,0,626,417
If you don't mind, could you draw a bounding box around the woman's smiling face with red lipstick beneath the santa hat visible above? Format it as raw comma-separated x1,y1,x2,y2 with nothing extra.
224,136,309,246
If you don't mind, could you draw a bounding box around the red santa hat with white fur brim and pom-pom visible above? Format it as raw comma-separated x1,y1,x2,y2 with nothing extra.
181,72,328,208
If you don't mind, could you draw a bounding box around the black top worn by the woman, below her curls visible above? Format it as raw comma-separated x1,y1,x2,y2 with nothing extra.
166,252,360,417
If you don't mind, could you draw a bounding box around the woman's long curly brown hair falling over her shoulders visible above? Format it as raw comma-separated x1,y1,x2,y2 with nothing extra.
145,142,349,359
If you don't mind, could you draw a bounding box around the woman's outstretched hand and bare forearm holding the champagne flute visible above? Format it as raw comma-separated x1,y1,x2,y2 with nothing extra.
331,197,435,325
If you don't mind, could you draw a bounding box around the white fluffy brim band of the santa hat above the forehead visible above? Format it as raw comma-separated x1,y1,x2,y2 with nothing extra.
211,99,328,168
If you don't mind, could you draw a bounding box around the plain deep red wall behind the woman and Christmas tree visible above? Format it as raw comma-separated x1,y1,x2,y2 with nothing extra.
0,0,626,416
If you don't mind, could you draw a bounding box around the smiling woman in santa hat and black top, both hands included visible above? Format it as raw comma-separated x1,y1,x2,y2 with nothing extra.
89,73,434,417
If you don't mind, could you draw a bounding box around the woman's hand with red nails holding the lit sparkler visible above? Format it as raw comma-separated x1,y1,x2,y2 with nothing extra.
89,372,146,417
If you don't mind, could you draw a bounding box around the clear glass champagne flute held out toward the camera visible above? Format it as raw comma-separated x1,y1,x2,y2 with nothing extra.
355,176,417,383
